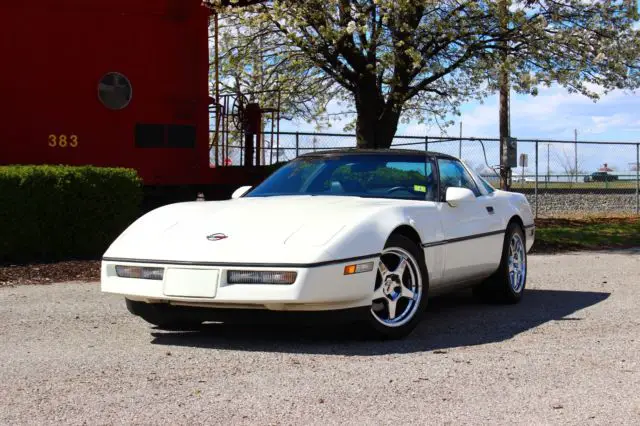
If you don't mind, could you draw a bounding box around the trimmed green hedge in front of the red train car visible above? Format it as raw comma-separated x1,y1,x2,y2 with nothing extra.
0,166,142,262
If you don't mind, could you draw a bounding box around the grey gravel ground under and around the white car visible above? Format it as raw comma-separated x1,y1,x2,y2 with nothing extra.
0,251,640,425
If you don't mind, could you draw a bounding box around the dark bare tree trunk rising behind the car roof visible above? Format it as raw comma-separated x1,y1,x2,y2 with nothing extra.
355,83,401,149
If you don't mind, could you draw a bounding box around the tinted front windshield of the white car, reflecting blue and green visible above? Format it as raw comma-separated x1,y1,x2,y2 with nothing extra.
246,154,437,200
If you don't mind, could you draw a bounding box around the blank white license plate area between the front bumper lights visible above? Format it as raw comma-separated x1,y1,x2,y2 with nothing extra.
164,268,219,297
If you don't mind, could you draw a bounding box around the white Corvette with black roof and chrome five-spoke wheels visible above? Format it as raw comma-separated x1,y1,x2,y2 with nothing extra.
101,149,535,338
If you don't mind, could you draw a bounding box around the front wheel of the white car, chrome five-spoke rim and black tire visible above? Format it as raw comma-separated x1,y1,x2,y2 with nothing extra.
363,235,429,339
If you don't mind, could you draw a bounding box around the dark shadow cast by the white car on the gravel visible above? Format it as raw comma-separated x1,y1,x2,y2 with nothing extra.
151,290,610,356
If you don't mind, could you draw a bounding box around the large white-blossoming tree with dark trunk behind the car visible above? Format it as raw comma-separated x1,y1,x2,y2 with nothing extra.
209,0,640,148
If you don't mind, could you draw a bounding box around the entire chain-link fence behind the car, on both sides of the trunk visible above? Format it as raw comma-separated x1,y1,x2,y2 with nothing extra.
211,132,640,217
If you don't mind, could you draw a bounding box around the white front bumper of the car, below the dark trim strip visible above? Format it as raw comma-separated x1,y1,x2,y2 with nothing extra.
101,258,378,311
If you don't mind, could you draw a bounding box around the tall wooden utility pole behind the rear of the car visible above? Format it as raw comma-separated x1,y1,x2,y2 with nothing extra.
500,0,511,191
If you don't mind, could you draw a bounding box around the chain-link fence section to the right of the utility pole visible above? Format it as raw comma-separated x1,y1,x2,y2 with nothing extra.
512,141,640,216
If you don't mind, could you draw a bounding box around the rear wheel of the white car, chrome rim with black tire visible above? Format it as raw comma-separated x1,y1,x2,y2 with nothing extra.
473,222,528,304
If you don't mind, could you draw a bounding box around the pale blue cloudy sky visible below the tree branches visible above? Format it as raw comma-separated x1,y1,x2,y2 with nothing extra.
281,86,640,173
